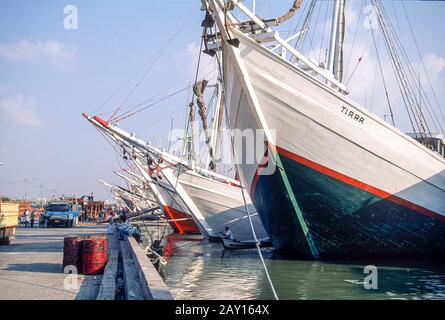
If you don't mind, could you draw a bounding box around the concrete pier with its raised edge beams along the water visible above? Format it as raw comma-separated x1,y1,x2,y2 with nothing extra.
0,224,173,300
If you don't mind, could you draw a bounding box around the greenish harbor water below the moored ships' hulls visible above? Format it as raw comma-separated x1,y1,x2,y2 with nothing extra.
141,228,445,300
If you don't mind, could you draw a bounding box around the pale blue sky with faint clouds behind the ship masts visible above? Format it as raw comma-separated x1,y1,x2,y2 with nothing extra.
0,0,445,198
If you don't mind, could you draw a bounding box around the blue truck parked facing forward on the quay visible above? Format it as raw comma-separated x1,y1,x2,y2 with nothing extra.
45,201,82,228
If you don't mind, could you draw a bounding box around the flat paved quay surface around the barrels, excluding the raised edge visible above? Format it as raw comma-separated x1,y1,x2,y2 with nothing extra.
0,224,107,300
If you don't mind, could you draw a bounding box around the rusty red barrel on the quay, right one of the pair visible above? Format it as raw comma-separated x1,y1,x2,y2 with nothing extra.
82,236,108,274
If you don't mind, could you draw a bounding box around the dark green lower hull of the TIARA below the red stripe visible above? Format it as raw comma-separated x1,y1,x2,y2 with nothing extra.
251,152,445,259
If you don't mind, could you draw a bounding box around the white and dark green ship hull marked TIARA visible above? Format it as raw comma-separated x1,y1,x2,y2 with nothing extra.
223,26,445,258
